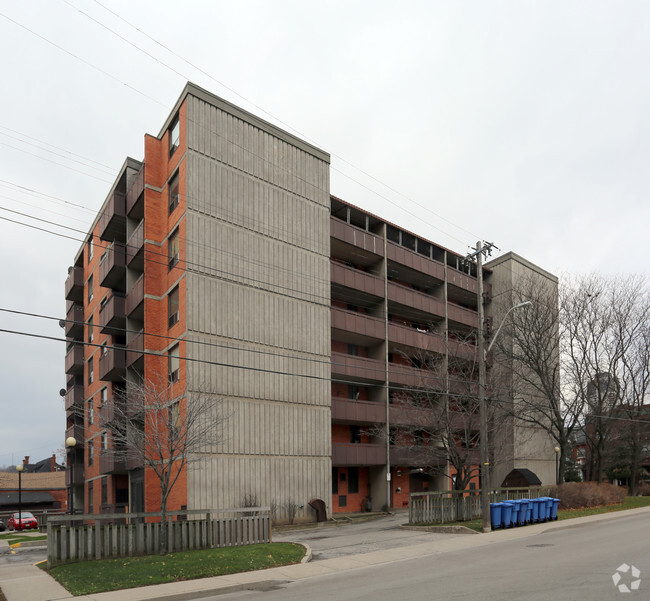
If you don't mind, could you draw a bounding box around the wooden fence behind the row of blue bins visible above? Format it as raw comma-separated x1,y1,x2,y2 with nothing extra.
409,486,551,524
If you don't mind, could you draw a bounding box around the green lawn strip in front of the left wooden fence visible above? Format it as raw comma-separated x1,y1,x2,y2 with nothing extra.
38,543,305,596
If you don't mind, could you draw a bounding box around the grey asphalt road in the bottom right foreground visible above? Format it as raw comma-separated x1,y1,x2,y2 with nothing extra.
209,514,650,601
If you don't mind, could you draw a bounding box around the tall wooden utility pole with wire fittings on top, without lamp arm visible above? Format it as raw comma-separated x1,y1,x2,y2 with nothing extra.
465,240,496,532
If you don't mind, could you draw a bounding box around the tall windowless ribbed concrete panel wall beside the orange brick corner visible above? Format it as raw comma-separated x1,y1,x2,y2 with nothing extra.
185,91,331,518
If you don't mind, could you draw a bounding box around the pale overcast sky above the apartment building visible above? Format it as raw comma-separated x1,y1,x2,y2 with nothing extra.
0,0,650,466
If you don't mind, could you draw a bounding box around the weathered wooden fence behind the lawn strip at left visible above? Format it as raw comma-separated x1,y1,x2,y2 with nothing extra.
47,507,271,567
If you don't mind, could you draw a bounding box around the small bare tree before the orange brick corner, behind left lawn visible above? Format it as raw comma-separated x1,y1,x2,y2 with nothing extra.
100,380,224,555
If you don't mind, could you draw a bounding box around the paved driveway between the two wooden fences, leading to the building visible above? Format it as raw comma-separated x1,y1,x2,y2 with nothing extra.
273,512,472,561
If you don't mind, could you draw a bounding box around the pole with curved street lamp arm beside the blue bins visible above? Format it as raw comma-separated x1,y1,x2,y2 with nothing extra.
477,298,532,532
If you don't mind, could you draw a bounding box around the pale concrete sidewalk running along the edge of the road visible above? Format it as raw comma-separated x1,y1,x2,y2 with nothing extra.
0,507,650,601
